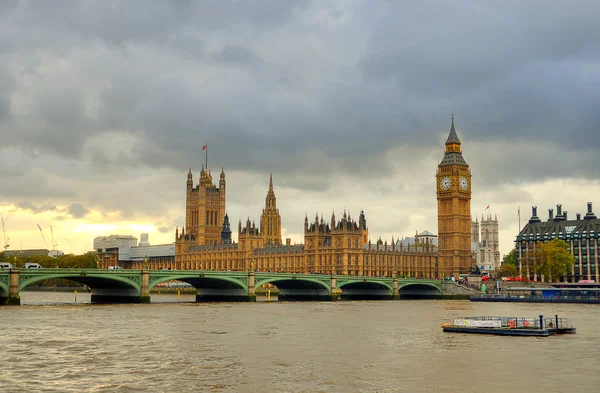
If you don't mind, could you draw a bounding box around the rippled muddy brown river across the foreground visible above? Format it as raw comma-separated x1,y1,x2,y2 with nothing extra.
0,292,600,393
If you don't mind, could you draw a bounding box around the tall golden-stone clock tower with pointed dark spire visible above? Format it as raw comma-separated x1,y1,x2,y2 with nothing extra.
436,114,473,278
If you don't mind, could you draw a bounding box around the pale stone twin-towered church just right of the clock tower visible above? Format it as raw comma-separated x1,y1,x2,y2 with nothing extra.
471,214,500,273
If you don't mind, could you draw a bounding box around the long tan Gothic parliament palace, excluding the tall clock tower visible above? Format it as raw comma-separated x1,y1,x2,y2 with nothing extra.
173,169,440,278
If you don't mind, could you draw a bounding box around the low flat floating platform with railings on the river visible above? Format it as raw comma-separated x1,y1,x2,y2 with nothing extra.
442,315,576,337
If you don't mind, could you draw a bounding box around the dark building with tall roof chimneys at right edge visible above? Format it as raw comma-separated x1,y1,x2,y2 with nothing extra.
515,202,600,282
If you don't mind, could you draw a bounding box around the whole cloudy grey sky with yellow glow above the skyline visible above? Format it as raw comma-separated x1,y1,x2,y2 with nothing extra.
0,0,600,254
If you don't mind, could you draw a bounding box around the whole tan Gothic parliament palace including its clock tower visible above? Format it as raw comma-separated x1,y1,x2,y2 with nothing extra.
171,120,472,278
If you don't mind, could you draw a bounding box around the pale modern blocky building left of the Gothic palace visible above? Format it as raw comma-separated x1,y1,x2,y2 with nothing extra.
94,233,175,269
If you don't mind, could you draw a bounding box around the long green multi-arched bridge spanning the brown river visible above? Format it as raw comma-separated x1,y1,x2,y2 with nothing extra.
0,269,442,305
